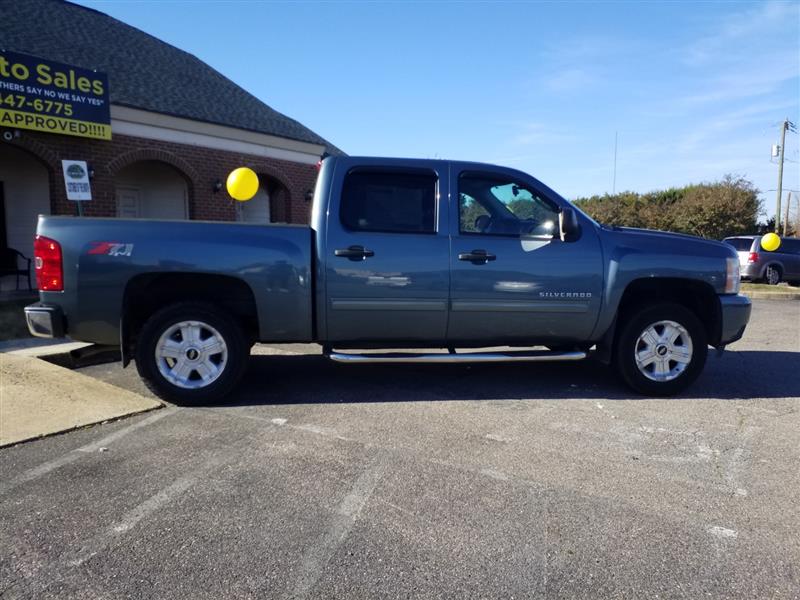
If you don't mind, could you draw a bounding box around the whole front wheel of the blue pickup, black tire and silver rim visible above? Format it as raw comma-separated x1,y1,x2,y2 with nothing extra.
614,303,708,396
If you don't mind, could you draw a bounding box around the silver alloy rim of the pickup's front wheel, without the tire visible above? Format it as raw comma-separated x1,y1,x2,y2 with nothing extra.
634,321,692,382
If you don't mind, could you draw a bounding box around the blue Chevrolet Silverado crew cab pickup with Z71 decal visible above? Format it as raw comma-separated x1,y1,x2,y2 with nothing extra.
25,157,750,403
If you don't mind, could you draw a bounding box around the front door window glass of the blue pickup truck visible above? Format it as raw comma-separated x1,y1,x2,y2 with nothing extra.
458,173,558,237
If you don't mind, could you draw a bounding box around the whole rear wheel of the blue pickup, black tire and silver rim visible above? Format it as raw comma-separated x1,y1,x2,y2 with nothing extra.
135,302,250,405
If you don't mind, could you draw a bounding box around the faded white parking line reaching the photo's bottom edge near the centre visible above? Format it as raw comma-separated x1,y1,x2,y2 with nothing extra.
288,454,388,598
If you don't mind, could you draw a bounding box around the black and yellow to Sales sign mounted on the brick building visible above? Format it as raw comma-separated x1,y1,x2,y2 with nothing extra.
0,50,111,140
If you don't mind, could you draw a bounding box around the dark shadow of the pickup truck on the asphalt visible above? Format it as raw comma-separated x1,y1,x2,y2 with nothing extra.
220,351,800,406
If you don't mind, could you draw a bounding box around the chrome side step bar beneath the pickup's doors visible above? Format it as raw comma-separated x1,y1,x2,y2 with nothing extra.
325,350,586,364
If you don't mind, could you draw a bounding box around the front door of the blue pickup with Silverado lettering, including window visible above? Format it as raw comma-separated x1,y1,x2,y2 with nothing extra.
448,169,603,346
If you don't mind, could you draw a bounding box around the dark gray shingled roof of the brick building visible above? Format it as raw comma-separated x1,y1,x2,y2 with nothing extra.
0,0,342,154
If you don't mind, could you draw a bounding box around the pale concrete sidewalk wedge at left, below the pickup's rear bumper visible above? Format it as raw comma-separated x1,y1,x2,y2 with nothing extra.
0,340,161,447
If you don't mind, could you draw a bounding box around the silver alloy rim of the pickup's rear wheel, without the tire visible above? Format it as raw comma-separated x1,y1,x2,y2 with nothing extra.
155,321,228,389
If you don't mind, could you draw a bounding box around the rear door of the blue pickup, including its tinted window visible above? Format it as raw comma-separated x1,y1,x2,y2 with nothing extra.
323,158,450,344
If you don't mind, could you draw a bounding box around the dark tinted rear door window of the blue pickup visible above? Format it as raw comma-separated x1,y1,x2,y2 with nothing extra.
339,171,437,233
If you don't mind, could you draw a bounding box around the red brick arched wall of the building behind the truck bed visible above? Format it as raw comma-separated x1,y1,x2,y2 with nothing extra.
0,130,317,223
